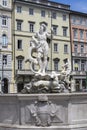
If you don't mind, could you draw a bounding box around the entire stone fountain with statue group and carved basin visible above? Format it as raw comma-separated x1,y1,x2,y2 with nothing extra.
0,24,87,130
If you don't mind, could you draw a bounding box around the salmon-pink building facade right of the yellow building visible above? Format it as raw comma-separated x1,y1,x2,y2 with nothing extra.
70,11,87,91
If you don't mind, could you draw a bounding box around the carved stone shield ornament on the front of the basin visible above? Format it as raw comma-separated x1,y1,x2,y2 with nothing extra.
27,95,60,127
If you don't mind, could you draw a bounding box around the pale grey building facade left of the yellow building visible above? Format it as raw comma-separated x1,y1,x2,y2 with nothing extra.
0,0,12,93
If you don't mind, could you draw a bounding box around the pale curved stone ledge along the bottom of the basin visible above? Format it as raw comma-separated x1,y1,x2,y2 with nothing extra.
0,124,87,130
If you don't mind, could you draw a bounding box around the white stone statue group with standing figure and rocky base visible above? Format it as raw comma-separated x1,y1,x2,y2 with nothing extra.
22,24,71,93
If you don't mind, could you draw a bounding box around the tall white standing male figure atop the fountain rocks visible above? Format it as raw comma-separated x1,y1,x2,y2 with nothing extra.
28,24,52,74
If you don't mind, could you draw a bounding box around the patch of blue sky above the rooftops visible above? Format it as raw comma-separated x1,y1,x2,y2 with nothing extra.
50,0,87,13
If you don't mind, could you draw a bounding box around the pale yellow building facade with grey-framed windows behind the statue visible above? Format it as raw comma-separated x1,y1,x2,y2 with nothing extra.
12,0,71,92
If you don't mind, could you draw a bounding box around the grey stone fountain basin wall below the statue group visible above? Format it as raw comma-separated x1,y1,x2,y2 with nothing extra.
0,93,87,130
